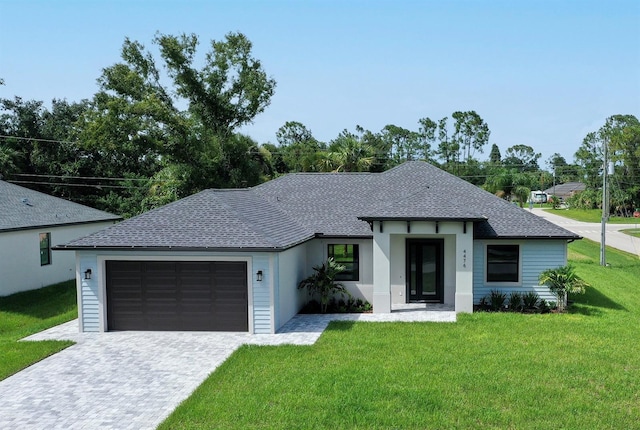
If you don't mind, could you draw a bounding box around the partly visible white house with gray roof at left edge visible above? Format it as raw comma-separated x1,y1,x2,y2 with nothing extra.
0,181,121,296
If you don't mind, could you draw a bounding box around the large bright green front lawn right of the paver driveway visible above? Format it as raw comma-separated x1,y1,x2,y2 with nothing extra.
160,240,640,429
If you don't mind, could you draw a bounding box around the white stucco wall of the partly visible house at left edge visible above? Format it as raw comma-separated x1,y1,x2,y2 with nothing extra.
0,221,113,296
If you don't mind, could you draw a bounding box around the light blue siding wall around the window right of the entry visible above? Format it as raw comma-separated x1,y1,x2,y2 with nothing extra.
473,240,567,304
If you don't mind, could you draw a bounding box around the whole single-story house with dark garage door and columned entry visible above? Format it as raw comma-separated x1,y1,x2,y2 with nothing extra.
60,161,580,333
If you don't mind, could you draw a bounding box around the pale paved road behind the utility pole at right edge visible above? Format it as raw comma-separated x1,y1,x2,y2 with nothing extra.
533,208,640,258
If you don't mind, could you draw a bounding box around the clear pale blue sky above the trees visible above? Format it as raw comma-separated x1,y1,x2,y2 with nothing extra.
0,0,640,167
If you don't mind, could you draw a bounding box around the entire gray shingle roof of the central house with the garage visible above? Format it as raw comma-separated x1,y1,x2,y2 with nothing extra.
60,161,579,250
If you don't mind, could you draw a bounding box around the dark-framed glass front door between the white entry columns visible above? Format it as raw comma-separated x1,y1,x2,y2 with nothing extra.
406,239,444,303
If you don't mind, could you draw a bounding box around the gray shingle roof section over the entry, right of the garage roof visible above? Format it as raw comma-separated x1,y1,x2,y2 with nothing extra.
256,161,579,239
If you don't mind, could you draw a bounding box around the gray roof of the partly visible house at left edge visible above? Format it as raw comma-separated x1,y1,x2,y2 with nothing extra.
0,181,121,232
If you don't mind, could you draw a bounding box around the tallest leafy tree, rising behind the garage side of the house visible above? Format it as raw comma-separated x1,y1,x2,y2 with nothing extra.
74,33,275,213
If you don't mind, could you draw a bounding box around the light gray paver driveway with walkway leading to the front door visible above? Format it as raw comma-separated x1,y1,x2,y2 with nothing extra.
0,305,456,430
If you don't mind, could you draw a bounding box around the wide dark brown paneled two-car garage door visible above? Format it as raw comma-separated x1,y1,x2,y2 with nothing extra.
106,260,249,331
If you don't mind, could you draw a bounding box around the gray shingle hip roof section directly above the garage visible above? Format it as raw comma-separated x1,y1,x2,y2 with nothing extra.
63,189,314,249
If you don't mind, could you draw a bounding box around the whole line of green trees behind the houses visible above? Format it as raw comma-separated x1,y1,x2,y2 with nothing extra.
0,33,640,217
